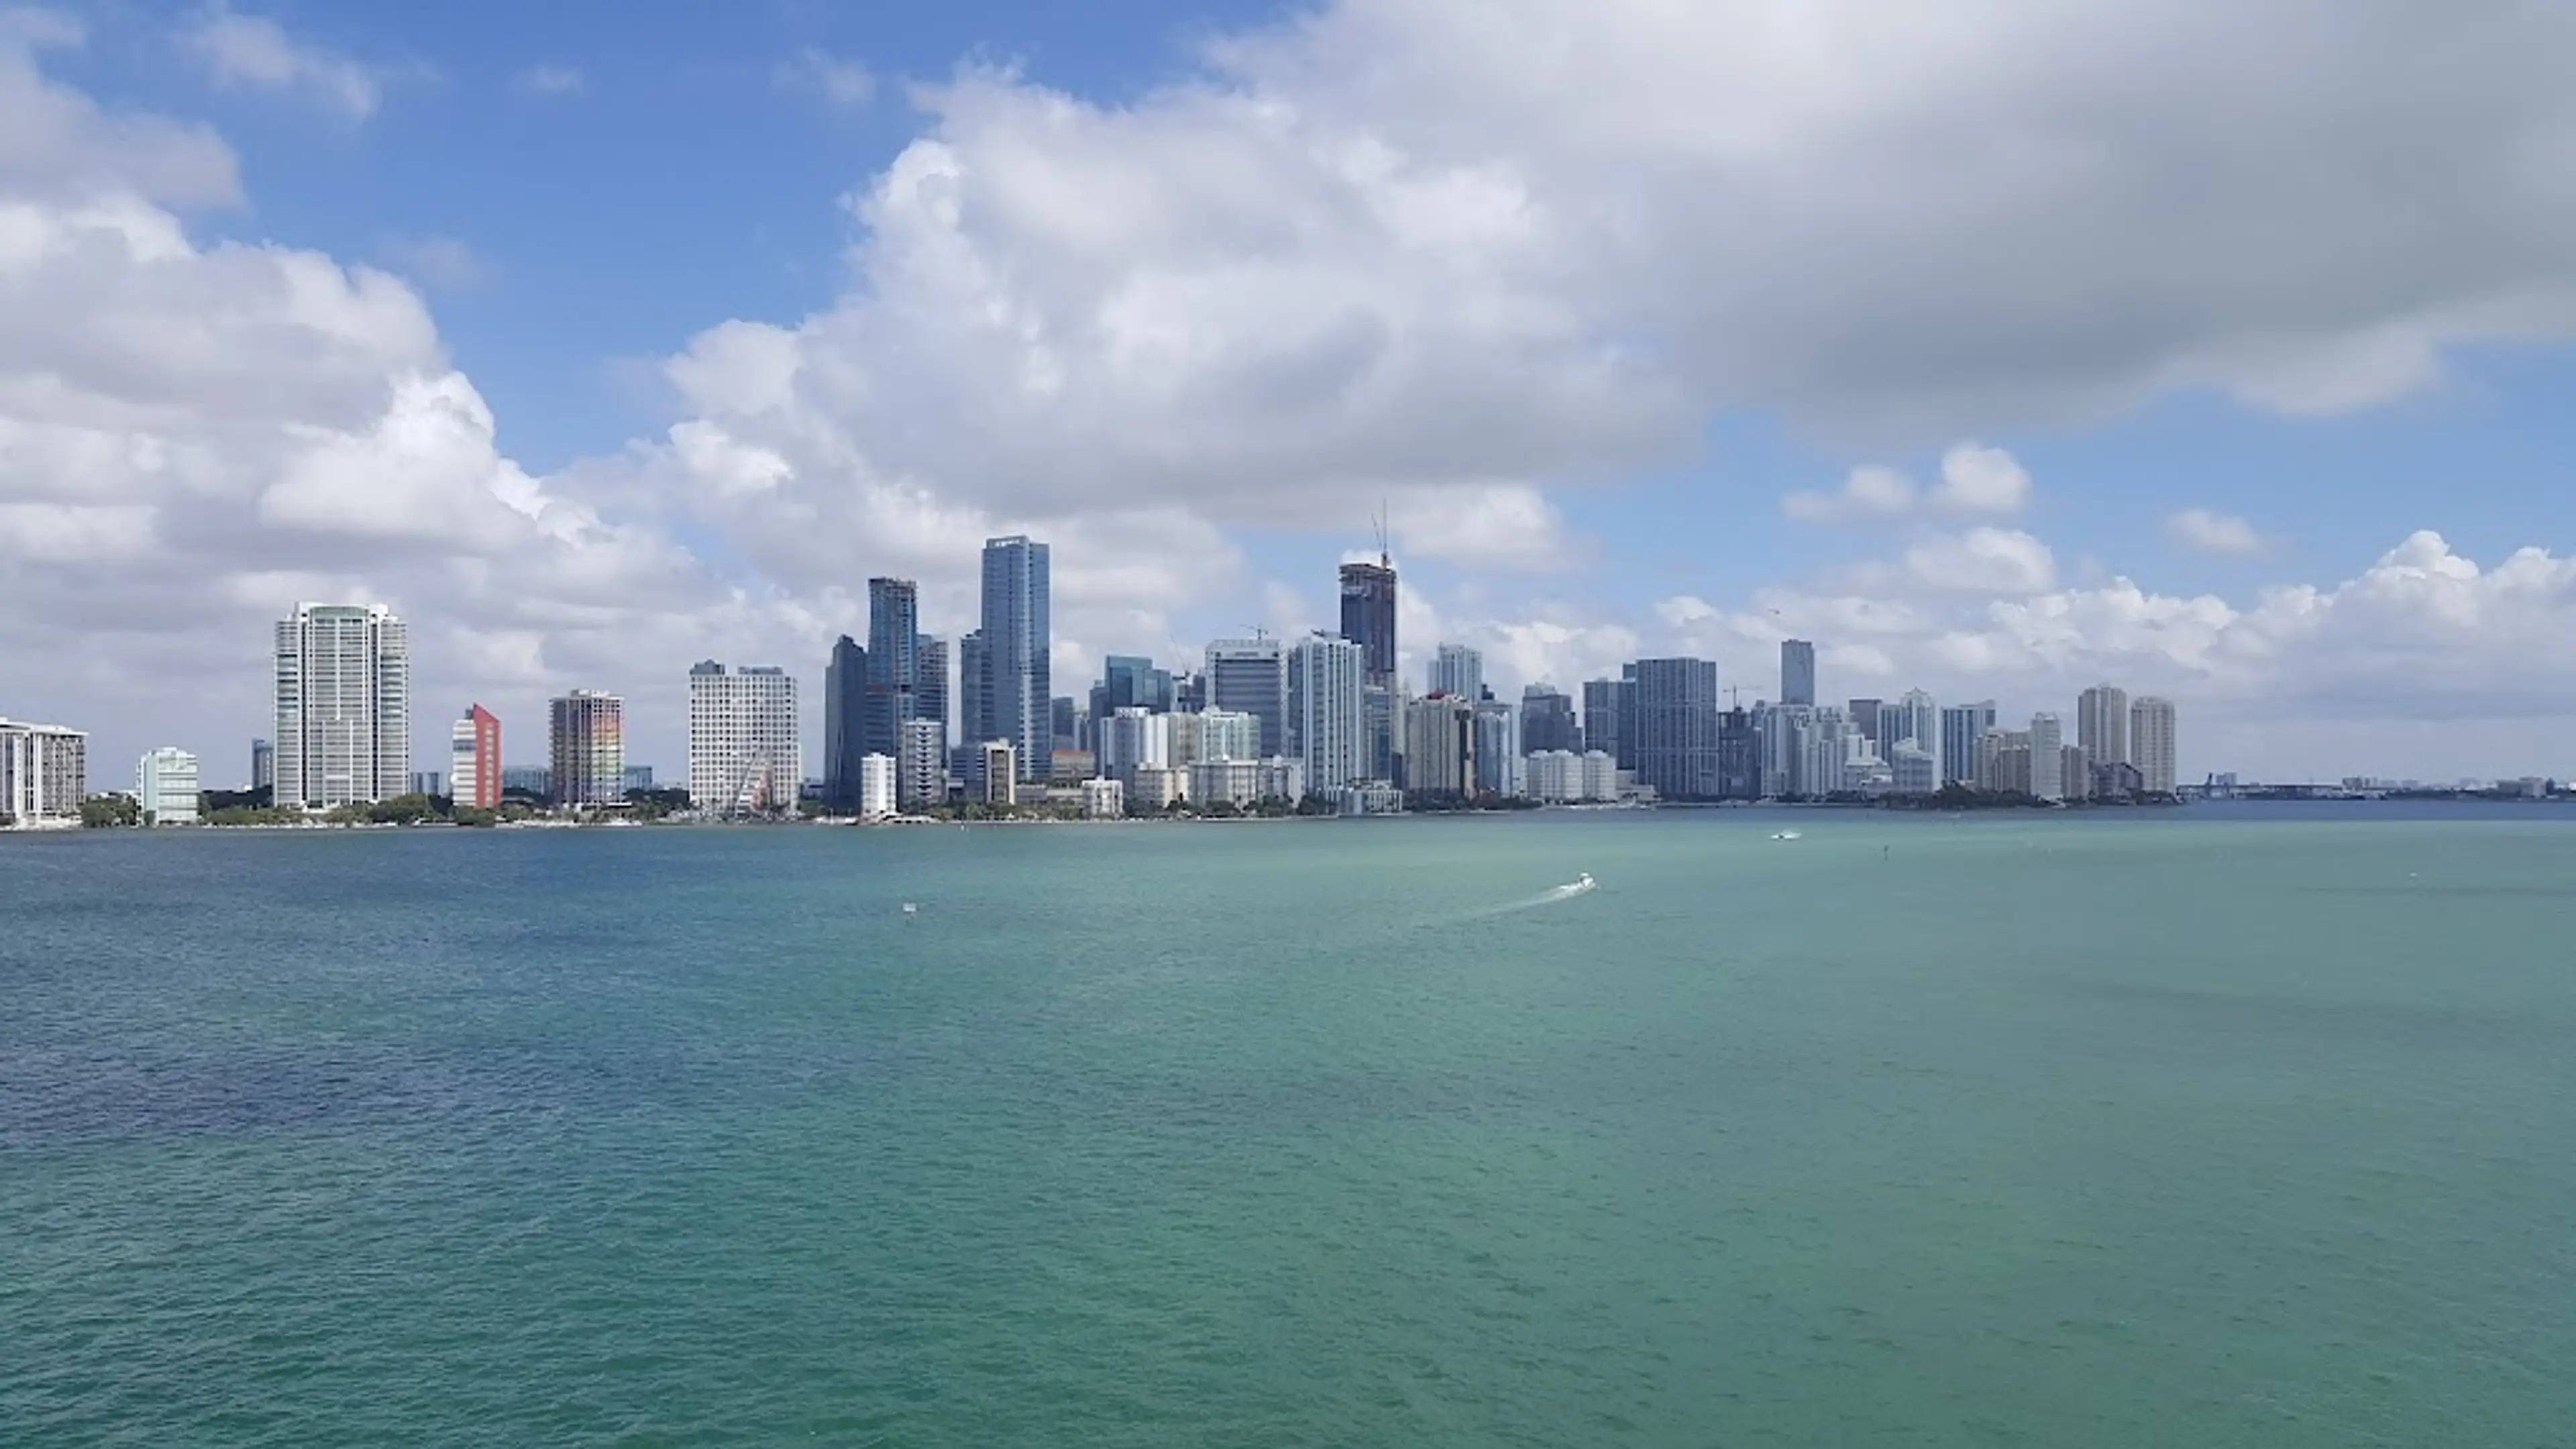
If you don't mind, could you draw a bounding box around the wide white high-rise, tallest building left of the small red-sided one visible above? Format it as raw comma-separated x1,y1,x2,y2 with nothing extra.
273,603,412,810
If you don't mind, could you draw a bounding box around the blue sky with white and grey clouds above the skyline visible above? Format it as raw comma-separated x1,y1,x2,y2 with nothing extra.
0,0,2576,784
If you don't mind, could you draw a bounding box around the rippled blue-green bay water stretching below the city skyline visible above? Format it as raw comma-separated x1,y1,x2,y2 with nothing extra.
0,810,2576,1449
